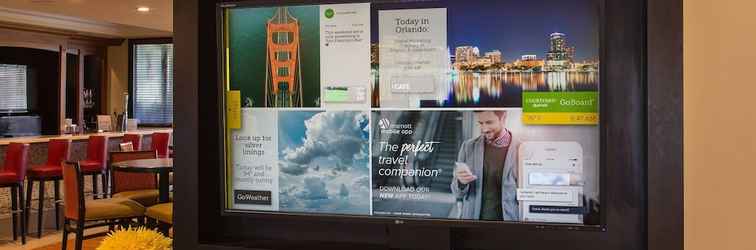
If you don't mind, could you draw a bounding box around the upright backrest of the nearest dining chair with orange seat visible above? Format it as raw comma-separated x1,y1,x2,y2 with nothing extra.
61,161,84,220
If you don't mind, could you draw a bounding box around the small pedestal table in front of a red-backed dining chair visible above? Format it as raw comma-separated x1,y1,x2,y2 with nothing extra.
113,158,173,203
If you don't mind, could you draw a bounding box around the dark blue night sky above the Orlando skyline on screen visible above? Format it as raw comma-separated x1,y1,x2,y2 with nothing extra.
372,0,599,62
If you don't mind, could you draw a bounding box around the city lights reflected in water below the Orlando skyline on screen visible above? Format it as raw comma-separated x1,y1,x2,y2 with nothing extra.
423,71,599,107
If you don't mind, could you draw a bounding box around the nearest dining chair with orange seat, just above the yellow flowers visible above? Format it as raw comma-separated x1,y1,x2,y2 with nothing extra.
62,161,145,250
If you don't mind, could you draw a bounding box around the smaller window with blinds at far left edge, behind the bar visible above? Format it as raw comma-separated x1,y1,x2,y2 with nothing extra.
0,64,28,112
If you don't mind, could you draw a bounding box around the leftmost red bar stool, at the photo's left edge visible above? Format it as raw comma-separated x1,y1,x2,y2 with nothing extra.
0,143,29,244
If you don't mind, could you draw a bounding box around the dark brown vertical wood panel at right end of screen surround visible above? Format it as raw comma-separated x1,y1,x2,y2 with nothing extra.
646,0,685,250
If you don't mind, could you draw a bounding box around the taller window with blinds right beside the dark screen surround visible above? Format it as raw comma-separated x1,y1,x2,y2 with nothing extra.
131,43,173,125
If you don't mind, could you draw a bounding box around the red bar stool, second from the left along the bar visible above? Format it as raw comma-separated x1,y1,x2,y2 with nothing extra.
24,139,71,238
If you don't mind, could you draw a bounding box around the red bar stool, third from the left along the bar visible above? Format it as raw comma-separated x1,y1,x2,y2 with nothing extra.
79,135,109,199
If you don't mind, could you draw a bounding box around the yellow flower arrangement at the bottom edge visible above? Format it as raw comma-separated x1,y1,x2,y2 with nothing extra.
97,227,173,250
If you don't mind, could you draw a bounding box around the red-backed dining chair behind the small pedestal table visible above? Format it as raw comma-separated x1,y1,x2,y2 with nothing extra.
110,151,160,207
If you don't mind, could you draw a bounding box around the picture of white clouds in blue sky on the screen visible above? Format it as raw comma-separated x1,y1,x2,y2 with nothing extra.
279,111,370,214
